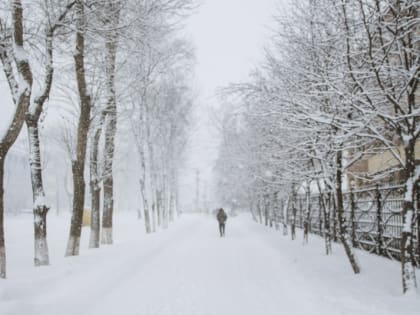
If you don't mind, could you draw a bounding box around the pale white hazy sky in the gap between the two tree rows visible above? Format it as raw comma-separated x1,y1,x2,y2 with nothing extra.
182,0,286,210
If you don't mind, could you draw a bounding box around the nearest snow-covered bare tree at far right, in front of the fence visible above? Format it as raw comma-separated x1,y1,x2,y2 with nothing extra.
341,0,420,292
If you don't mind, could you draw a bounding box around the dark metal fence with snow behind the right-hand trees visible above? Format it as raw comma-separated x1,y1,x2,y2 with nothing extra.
278,186,420,266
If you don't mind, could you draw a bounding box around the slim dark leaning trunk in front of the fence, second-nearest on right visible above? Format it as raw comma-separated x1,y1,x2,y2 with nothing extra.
336,150,360,274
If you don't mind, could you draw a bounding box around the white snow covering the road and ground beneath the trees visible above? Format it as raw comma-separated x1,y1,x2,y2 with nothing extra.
0,214,420,315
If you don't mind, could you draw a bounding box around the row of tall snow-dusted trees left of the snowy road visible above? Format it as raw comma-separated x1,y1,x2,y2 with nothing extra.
0,0,194,278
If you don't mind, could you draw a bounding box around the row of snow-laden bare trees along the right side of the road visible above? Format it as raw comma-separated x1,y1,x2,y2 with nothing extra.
217,0,420,292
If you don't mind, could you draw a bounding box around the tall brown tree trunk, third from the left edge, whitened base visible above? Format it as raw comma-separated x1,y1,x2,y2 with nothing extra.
65,0,91,256
